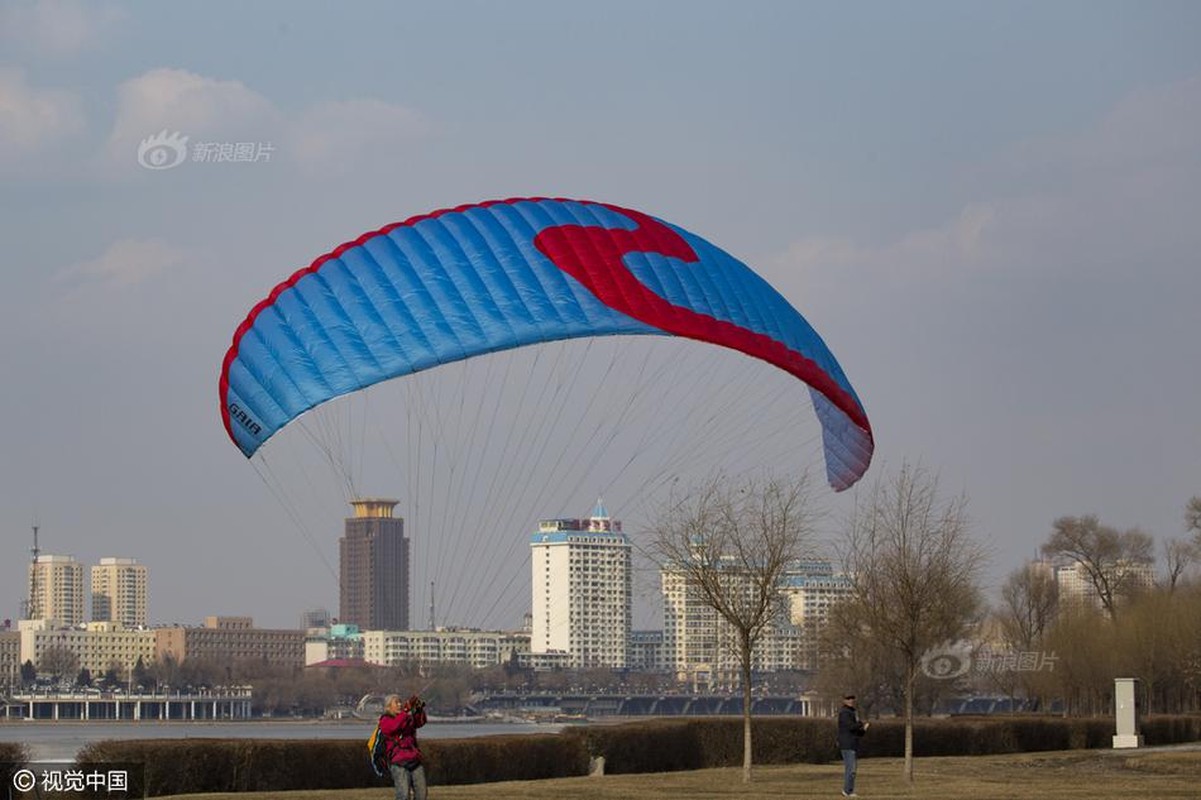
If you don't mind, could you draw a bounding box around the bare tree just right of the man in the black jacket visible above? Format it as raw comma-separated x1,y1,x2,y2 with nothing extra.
843,464,985,782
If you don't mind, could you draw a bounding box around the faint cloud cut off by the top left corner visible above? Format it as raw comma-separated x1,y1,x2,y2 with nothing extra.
0,0,124,56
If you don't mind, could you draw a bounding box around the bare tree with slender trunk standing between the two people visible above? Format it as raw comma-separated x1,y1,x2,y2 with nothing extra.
651,476,815,782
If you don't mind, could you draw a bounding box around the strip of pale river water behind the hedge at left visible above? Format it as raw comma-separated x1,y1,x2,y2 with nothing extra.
0,720,564,762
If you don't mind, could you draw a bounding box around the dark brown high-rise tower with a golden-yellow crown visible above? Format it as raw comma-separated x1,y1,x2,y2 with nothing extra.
337,497,410,631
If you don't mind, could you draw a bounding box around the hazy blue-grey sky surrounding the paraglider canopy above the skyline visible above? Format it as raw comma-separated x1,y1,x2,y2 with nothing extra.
0,0,1201,627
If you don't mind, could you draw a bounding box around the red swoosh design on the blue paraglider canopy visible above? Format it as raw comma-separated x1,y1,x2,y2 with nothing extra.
534,203,871,435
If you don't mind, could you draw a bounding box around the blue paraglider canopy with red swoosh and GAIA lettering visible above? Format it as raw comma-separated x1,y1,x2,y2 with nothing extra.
220,198,873,490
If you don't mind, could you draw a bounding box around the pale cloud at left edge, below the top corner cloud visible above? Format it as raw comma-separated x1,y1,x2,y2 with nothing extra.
0,68,85,163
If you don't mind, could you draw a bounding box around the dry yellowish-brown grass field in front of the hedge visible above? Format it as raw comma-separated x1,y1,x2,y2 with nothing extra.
159,748,1201,800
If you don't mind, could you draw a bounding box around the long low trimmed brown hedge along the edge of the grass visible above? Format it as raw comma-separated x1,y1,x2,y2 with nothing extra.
75,716,1201,796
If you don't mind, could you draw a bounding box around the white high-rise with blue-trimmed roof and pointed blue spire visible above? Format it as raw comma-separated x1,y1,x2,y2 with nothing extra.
530,501,633,668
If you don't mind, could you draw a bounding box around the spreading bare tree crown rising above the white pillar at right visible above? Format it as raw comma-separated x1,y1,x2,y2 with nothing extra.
1042,514,1154,620
